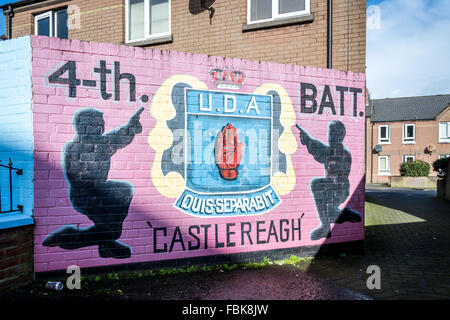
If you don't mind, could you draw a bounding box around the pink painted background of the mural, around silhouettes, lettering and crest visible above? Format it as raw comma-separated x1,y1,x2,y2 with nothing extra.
31,37,365,272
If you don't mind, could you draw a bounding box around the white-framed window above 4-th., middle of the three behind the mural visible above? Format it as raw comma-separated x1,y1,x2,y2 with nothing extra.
126,0,170,42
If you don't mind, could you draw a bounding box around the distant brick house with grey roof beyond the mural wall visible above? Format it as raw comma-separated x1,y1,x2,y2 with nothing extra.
366,95,450,183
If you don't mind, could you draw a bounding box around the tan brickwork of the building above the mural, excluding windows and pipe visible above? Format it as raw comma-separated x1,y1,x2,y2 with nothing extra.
6,0,366,73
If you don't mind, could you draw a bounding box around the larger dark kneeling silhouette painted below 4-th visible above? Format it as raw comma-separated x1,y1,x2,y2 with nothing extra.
43,108,144,259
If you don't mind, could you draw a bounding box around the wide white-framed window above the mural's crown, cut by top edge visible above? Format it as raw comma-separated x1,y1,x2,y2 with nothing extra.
247,0,310,23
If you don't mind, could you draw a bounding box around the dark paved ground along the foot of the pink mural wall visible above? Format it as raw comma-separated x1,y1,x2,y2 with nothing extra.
0,188,450,300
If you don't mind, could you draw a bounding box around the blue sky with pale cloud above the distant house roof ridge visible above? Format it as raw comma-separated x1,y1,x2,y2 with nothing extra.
0,0,450,99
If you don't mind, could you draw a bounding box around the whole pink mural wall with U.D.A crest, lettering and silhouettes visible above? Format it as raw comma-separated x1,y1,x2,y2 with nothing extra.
31,37,365,272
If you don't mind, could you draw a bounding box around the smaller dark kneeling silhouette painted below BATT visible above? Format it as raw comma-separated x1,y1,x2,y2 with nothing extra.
296,121,361,240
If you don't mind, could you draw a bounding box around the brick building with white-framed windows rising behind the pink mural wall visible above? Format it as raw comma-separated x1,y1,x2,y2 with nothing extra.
2,0,366,72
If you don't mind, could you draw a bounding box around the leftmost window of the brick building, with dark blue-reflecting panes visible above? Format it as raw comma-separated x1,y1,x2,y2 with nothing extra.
34,9,69,39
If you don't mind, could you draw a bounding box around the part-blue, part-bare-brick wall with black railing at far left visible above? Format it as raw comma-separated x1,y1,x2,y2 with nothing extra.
0,37,33,291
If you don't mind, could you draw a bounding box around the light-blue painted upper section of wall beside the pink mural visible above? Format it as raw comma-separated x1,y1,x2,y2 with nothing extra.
0,37,33,230
